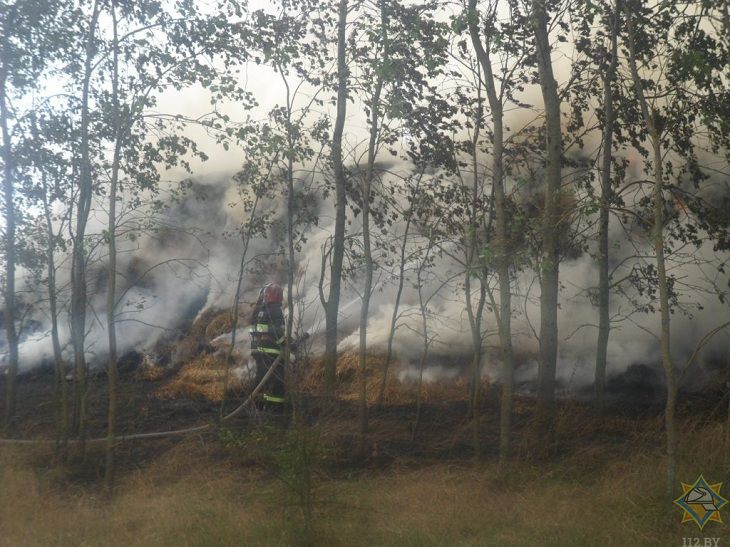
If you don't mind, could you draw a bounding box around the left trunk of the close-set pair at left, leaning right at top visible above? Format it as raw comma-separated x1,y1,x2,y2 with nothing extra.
71,1,99,457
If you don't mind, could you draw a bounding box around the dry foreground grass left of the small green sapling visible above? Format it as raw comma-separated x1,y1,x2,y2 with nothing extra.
0,444,274,547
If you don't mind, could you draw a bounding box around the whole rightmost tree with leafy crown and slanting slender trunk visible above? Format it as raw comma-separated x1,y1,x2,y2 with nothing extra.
625,2,730,491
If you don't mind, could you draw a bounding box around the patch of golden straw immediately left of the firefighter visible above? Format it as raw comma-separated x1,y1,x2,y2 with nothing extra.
157,353,243,402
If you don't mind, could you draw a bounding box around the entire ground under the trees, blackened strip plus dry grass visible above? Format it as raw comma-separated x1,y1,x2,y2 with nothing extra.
0,311,729,545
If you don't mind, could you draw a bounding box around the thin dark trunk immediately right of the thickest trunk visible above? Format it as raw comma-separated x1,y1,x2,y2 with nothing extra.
594,0,621,405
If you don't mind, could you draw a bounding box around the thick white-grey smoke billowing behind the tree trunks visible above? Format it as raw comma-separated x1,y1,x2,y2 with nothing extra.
2,156,728,396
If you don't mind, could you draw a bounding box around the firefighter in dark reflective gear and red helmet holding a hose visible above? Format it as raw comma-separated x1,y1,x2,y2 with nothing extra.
251,283,286,408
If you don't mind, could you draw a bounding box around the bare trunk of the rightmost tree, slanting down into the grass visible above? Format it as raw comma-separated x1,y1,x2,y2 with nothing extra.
627,7,677,494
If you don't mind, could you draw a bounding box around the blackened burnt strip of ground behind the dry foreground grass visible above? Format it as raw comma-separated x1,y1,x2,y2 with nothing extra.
0,367,728,482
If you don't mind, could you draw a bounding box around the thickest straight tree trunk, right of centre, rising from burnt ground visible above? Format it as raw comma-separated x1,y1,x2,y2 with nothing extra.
532,0,562,434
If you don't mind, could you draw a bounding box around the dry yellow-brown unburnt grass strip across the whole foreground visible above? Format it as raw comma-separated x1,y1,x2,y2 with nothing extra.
0,422,730,547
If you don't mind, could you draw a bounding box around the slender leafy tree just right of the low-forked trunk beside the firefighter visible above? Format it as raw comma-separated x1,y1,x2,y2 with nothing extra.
351,0,446,448
